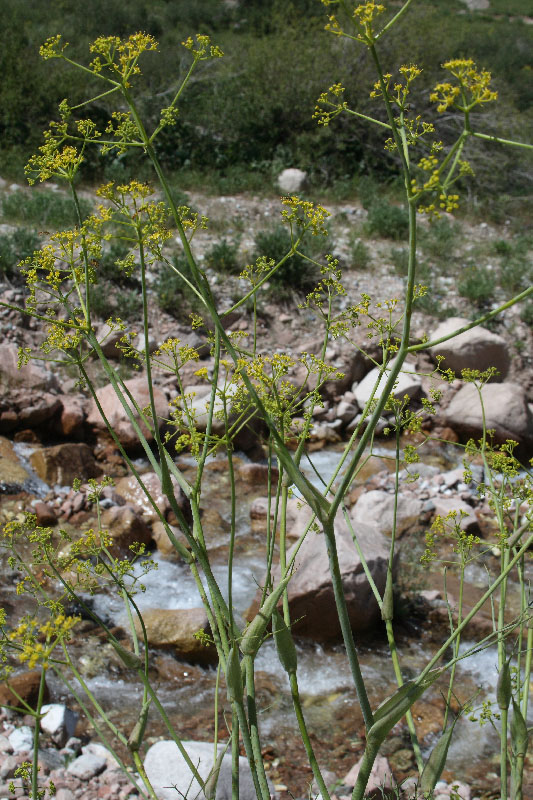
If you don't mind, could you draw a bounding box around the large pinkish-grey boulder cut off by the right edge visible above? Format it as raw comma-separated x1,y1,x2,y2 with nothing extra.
443,383,533,445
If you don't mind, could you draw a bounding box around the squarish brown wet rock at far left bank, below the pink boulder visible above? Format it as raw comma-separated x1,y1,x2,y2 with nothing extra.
30,442,101,486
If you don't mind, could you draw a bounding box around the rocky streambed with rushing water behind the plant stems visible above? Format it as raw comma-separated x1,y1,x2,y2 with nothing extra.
0,276,533,800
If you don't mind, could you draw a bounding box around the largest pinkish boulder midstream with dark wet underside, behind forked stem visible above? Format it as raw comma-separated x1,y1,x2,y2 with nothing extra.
246,506,389,642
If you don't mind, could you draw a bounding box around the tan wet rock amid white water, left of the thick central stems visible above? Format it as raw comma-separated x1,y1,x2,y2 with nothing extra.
136,608,216,663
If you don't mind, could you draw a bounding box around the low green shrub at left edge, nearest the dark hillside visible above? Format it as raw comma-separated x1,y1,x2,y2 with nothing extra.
2,190,92,228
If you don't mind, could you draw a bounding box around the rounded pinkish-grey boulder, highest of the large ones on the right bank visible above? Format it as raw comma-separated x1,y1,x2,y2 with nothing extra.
430,317,511,380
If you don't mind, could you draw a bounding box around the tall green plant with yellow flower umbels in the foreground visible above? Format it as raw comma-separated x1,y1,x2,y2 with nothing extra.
0,6,533,800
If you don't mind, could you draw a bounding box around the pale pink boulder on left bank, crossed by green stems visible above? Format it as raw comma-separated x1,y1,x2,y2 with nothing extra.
87,377,168,448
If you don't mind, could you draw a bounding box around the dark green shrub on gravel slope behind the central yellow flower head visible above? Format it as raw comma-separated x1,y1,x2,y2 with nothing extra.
253,225,318,295
